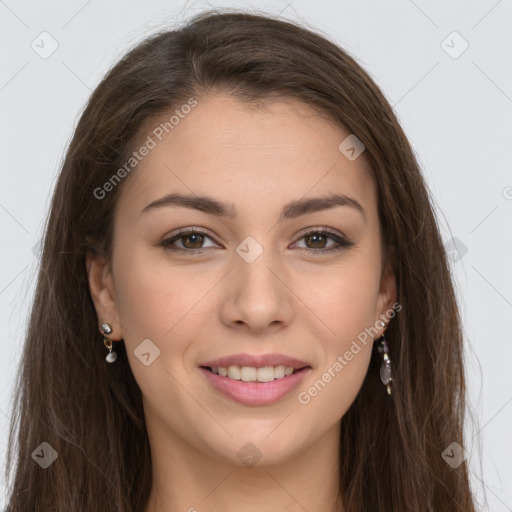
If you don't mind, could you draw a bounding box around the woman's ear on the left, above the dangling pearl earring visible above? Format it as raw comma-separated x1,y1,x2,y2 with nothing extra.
85,251,123,341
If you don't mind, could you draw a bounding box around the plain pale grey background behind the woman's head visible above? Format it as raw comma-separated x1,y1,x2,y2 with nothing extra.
0,0,512,512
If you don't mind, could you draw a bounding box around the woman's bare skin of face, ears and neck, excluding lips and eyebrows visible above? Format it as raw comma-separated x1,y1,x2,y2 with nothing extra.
87,93,396,512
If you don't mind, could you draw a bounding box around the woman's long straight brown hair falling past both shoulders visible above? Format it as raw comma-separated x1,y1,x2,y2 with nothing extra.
6,10,474,512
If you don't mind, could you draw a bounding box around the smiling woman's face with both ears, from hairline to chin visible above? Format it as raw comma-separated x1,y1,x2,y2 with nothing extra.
88,94,396,465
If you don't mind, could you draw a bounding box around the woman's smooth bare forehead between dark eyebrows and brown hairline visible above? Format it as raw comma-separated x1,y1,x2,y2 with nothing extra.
119,95,376,223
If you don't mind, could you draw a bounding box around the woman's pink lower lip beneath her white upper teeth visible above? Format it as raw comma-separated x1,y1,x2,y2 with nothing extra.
200,361,312,405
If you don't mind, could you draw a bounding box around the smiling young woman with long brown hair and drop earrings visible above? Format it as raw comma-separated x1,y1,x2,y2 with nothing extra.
2,8,474,512
